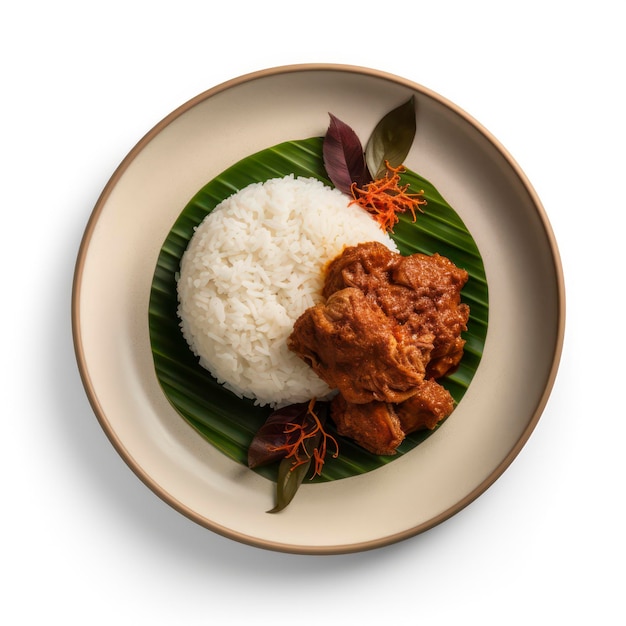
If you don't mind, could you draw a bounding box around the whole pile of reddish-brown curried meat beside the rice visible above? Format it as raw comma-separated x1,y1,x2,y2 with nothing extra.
288,242,469,454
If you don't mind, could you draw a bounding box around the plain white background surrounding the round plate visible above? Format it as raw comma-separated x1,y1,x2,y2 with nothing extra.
0,0,626,626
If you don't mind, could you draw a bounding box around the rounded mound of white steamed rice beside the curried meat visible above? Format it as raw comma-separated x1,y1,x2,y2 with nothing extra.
178,175,397,407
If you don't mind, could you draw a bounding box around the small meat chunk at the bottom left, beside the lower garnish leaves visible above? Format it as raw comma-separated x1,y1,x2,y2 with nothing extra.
330,394,404,455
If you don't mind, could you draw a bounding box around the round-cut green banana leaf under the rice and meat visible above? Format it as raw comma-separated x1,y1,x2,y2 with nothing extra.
149,137,489,482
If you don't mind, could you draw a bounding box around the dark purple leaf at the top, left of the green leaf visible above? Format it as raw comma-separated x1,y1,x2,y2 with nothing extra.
322,113,370,194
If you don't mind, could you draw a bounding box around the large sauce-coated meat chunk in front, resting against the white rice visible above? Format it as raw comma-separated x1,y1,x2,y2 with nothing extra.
287,287,434,404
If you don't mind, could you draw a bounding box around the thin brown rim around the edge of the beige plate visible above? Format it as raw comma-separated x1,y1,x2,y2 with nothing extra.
71,63,566,554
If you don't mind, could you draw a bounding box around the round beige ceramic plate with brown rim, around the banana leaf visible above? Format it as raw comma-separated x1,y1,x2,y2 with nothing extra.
72,65,565,554
